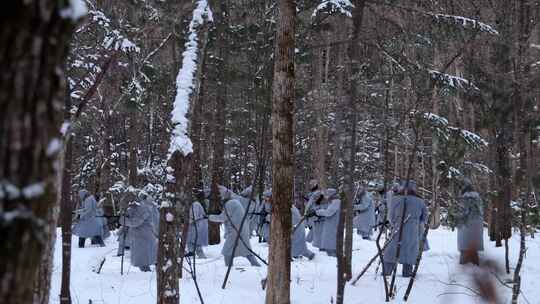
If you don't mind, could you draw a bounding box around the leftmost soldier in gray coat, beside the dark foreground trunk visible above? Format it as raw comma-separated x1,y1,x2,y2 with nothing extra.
73,189,105,248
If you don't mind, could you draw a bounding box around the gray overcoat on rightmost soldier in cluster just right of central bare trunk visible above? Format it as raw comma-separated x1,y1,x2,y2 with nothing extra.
313,198,341,250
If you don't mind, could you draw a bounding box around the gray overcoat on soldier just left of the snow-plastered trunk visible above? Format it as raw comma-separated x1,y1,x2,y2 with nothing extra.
125,203,158,267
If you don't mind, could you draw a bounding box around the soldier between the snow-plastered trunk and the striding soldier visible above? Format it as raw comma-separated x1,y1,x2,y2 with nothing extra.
185,201,208,259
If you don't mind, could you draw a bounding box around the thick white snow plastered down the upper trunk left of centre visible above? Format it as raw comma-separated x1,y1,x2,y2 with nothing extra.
169,0,212,157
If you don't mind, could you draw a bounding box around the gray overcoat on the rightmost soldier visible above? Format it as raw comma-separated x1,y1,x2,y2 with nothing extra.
457,191,484,251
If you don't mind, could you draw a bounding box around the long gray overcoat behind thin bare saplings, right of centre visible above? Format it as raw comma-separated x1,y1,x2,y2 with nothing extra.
384,195,427,264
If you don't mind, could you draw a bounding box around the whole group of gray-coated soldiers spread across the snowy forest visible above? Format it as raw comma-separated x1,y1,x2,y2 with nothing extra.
74,176,483,277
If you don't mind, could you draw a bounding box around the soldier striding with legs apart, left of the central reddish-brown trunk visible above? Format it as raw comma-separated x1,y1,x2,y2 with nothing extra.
208,186,261,266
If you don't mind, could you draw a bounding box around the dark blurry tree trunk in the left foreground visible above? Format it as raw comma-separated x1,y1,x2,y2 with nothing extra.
0,1,76,304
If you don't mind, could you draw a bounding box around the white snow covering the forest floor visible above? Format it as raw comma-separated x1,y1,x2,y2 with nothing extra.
50,229,540,304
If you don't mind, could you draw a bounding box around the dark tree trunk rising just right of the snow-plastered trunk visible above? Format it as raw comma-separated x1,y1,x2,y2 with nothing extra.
208,0,229,245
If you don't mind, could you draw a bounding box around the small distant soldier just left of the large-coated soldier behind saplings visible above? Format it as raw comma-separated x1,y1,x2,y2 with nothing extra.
353,186,375,240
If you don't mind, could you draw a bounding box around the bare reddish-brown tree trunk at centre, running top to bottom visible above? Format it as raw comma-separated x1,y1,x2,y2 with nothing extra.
266,0,296,304
